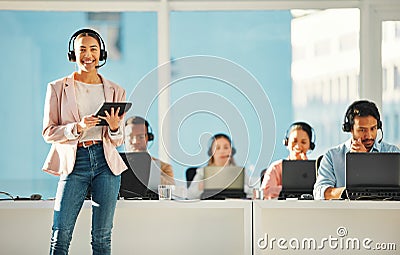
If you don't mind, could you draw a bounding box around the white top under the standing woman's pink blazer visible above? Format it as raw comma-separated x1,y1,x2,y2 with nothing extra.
75,81,105,141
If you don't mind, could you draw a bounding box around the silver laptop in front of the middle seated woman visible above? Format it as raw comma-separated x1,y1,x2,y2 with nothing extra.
201,166,246,199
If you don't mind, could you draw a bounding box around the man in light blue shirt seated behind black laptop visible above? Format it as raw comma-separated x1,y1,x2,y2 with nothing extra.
314,100,400,200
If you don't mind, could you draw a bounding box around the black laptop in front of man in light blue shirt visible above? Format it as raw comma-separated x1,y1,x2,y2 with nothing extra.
346,152,400,200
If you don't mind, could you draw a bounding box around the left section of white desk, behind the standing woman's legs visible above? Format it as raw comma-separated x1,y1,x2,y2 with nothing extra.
0,200,252,255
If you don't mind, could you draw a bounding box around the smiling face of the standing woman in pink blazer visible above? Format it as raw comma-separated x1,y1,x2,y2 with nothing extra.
74,34,100,72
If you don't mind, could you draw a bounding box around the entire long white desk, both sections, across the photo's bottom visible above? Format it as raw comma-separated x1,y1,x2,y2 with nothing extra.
0,200,400,255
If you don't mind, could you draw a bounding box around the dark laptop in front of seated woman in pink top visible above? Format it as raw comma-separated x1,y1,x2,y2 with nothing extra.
278,160,316,199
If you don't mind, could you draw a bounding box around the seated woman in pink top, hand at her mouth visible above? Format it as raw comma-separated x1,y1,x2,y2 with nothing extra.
261,122,315,199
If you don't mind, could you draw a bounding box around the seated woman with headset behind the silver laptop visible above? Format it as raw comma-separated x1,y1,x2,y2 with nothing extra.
187,133,236,199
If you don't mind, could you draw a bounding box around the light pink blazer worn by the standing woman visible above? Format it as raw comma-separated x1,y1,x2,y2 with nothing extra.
42,71,127,175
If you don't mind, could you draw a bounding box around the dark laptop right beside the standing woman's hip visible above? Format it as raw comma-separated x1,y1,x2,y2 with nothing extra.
119,152,158,199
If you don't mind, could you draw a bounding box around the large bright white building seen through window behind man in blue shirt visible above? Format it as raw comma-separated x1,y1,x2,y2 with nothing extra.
292,9,359,155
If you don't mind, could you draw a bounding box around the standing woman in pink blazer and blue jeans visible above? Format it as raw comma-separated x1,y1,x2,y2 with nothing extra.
42,29,127,255
